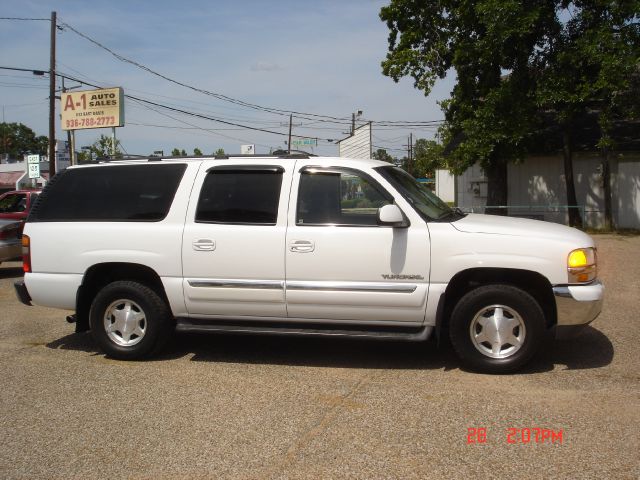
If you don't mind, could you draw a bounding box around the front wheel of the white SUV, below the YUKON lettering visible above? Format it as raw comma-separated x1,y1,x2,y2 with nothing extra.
449,285,545,373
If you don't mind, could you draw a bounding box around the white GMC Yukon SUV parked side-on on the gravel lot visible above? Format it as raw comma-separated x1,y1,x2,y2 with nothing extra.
16,155,603,373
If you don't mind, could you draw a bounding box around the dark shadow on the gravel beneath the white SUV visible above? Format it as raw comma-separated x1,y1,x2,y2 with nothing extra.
47,327,614,375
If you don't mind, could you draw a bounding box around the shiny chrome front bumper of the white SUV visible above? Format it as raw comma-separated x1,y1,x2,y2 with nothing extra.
553,280,604,338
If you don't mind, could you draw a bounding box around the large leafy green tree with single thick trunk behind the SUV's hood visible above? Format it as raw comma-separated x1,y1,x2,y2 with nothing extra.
380,0,554,213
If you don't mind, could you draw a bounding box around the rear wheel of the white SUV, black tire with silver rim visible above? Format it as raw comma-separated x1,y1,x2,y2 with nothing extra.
89,281,173,360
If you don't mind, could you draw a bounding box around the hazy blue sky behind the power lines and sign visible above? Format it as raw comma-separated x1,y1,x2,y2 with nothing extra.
0,0,452,157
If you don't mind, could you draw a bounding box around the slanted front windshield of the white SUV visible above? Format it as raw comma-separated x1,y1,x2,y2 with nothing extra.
376,167,457,221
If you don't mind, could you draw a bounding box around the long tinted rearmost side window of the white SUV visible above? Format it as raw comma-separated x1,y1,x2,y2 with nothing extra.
29,164,187,222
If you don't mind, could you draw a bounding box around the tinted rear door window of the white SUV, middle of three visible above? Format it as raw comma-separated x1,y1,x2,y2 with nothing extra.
196,167,283,225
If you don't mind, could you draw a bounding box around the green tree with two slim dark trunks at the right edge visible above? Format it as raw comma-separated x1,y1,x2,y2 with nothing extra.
536,0,640,229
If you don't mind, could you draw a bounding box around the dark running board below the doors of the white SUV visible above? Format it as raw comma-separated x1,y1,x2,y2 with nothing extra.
176,318,433,342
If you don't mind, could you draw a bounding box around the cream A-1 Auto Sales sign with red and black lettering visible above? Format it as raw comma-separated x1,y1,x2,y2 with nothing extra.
61,87,124,130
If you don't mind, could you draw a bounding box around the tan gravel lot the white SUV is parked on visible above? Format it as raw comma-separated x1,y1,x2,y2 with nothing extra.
0,235,640,479
